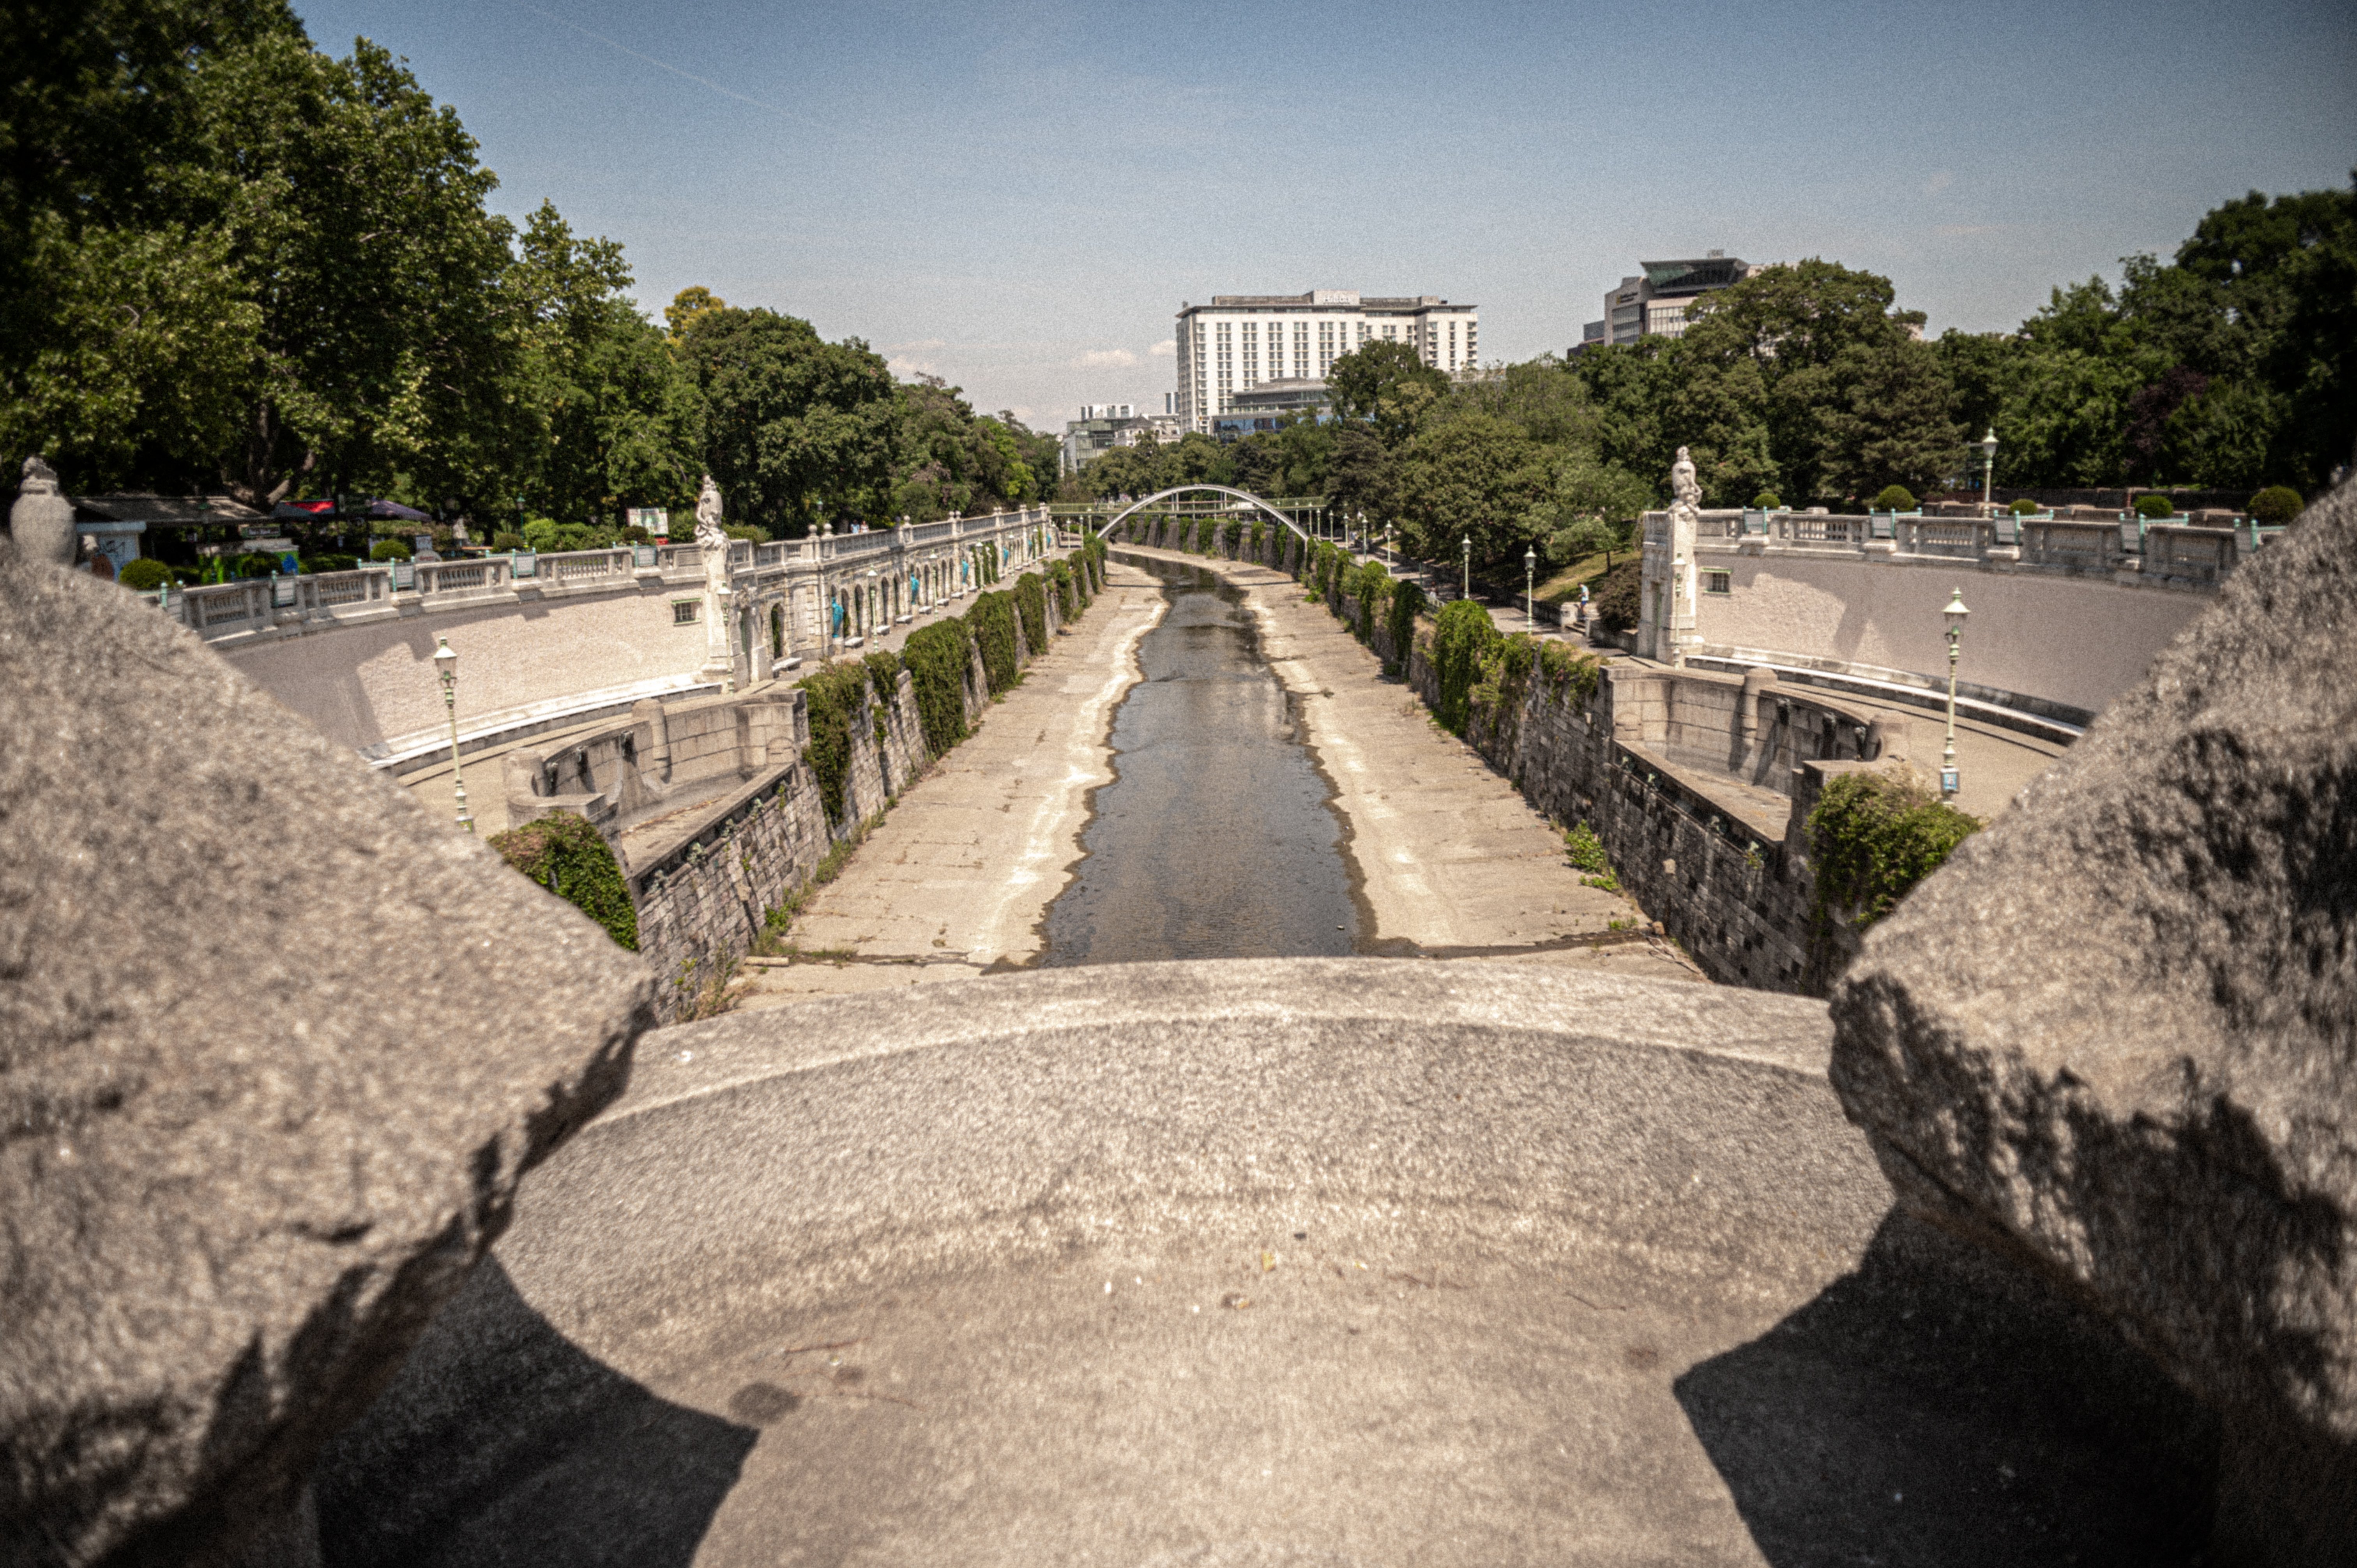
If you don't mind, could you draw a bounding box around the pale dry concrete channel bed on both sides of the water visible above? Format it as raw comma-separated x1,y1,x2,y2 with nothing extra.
742,545,1700,1007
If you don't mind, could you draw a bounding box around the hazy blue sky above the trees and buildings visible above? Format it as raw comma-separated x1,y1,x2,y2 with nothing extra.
297,0,2357,431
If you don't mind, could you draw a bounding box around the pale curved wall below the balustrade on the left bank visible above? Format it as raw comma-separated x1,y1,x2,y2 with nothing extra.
219,585,705,754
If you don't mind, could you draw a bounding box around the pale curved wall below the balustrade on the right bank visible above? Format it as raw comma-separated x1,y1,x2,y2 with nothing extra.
1695,552,2216,712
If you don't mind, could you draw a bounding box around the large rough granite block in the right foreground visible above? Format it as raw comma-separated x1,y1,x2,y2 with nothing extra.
1831,486,2357,1561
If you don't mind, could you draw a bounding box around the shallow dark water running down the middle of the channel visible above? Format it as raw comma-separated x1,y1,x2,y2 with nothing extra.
1037,559,1360,967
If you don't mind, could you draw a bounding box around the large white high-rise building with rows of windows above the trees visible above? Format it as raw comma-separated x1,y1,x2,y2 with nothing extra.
1171,288,1480,431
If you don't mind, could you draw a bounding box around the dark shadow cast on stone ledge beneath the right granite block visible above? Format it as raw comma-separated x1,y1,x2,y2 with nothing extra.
1676,1212,2218,1568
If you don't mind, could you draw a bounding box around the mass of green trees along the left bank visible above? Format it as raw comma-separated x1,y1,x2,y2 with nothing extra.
0,0,1053,538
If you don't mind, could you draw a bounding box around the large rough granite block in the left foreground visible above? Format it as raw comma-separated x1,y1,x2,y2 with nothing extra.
0,552,650,1566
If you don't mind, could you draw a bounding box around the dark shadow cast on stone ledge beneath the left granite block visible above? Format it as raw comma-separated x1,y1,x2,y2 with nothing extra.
316,1257,759,1568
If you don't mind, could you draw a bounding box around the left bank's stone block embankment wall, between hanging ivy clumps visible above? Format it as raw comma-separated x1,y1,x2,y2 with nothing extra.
507,556,1089,1021
